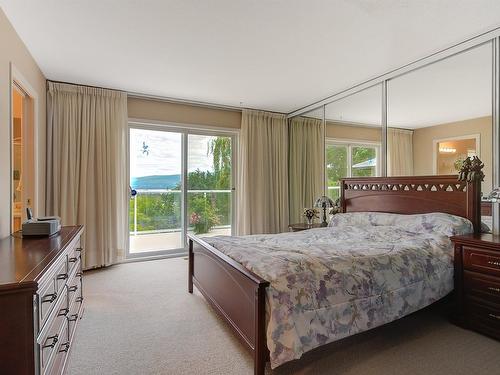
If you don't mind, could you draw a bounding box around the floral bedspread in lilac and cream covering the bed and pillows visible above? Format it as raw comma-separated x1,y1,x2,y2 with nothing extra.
205,213,472,368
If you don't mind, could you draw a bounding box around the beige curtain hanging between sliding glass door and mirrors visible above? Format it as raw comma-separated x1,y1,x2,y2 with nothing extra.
236,110,288,235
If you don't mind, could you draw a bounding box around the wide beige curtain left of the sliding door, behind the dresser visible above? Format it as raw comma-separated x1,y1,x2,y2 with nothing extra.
46,82,128,269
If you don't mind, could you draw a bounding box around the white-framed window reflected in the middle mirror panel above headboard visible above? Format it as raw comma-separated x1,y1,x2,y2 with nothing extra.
326,140,380,200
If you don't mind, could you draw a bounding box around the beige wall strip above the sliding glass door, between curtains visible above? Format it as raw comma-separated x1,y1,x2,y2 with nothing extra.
128,98,241,129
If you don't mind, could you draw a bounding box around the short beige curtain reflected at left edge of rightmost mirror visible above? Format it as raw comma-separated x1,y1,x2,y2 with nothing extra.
387,128,413,176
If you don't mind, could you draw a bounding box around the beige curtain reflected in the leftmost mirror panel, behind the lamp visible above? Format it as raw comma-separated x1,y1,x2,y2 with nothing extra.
288,117,325,223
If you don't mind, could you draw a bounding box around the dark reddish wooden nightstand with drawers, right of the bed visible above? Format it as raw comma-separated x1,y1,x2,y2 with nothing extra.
451,233,500,339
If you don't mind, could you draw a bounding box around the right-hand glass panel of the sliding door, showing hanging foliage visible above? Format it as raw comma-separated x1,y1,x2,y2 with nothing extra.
187,134,232,236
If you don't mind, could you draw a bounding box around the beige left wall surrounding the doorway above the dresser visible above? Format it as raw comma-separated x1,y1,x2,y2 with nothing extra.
0,9,45,237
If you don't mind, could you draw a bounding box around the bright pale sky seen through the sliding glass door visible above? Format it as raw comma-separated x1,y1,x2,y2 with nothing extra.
130,129,217,177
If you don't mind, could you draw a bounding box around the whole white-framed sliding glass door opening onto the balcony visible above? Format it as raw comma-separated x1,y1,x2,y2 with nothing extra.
128,125,235,257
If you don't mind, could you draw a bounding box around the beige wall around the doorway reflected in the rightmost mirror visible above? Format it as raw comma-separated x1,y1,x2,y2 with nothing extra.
413,116,493,193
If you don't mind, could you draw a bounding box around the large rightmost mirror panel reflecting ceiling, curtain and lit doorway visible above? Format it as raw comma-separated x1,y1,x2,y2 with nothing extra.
387,43,493,232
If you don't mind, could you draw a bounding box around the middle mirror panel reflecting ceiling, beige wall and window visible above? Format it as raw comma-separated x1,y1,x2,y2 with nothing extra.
325,85,382,200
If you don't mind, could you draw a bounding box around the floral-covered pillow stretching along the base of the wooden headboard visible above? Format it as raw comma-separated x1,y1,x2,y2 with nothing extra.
329,212,473,236
